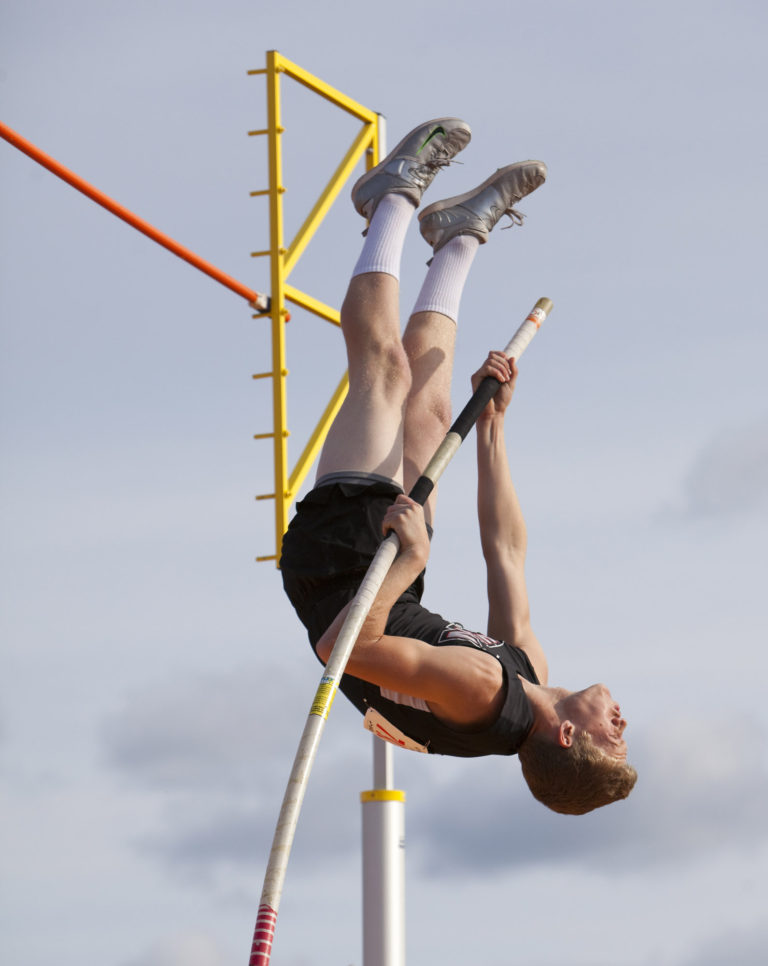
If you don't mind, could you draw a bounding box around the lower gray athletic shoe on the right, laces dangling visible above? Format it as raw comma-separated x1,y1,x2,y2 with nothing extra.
419,161,547,252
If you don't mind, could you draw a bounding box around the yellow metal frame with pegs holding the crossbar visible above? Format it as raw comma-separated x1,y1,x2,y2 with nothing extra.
248,50,381,560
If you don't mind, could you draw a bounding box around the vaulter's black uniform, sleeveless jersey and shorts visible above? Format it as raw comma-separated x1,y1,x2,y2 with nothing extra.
280,482,539,757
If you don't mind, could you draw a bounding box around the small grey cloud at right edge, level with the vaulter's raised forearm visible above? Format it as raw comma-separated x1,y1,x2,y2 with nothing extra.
664,417,768,519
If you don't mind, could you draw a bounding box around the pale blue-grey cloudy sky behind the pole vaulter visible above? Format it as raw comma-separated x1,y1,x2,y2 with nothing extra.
0,0,768,966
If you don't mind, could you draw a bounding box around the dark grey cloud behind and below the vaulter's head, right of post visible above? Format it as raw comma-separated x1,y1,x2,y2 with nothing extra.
408,720,768,876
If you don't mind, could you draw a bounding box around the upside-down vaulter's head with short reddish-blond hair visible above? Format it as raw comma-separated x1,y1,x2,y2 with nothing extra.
518,684,637,815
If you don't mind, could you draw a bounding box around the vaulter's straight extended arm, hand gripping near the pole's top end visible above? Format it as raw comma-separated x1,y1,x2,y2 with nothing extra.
472,352,548,684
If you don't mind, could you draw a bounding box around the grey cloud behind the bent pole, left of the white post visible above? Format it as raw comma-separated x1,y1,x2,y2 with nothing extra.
103,662,370,883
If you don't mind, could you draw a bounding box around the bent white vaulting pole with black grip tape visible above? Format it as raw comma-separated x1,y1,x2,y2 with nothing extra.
249,298,552,966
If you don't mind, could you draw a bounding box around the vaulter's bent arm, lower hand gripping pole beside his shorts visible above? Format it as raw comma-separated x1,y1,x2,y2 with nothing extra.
317,495,504,727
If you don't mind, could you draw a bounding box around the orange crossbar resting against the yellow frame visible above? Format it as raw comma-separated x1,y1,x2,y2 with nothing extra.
0,121,269,310
